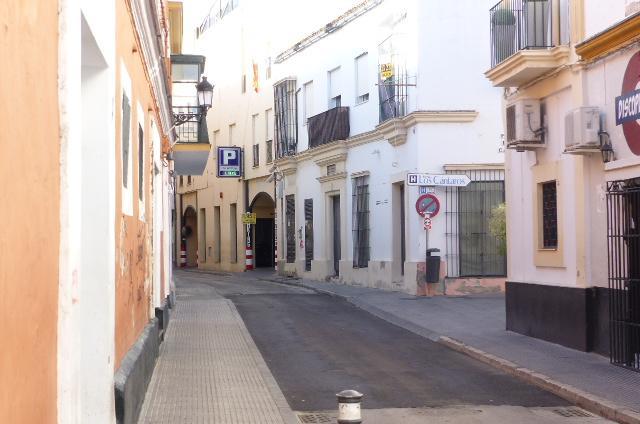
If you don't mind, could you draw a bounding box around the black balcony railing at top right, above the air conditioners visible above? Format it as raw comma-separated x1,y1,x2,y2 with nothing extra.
489,0,553,67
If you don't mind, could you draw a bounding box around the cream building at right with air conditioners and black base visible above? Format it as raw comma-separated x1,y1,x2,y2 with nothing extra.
485,0,640,370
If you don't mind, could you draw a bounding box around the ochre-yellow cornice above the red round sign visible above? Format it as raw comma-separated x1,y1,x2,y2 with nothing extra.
576,13,640,61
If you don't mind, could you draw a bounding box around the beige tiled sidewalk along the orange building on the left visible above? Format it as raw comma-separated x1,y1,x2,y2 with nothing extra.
139,288,293,424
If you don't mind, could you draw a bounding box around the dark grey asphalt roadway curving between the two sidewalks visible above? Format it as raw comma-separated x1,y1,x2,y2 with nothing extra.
207,278,567,411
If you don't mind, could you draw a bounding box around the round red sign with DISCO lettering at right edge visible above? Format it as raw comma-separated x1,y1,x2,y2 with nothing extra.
615,52,640,156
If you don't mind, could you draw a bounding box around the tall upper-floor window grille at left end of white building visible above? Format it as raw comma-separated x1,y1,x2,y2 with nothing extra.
273,79,298,158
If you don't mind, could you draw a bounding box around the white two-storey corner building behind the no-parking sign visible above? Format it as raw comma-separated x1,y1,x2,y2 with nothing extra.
273,0,506,294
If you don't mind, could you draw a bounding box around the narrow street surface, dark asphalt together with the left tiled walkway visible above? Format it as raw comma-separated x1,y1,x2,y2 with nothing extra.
140,271,604,423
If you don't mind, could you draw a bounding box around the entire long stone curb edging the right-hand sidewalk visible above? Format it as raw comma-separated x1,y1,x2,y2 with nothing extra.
268,279,640,424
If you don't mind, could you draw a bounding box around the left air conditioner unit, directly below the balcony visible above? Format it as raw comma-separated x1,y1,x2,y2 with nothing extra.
506,99,544,150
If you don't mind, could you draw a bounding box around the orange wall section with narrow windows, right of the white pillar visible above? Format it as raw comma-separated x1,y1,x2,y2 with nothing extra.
115,1,165,369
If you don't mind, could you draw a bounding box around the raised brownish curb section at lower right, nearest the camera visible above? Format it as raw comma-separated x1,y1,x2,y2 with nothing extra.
438,336,640,424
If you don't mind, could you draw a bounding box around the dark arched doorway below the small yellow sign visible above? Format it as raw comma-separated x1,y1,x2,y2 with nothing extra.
251,192,276,268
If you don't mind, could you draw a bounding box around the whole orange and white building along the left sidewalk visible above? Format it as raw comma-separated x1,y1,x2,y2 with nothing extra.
0,0,174,423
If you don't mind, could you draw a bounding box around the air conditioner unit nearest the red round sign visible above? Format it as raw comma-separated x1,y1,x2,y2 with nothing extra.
564,106,600,153
